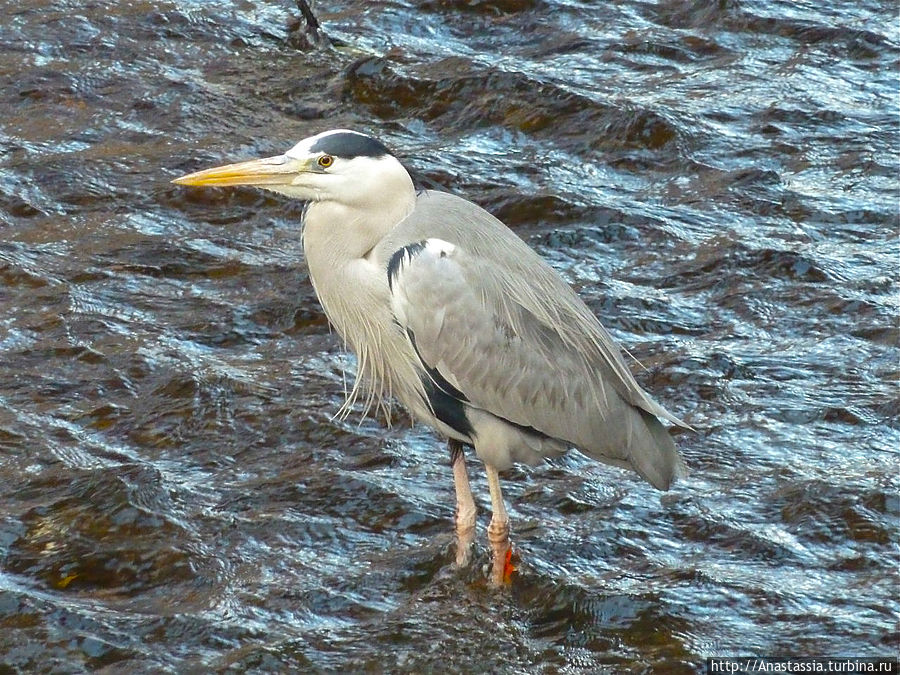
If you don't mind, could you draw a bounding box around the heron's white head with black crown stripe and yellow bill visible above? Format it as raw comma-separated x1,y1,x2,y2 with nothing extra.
172,129,414,206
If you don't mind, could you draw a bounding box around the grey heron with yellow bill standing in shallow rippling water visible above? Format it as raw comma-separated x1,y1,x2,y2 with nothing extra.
173,129,687,583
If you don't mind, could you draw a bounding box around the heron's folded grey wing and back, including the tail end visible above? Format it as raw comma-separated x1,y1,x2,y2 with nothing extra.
388,193,684,488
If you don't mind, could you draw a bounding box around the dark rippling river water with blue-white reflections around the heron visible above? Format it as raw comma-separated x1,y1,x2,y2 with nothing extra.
0,0,900,673
